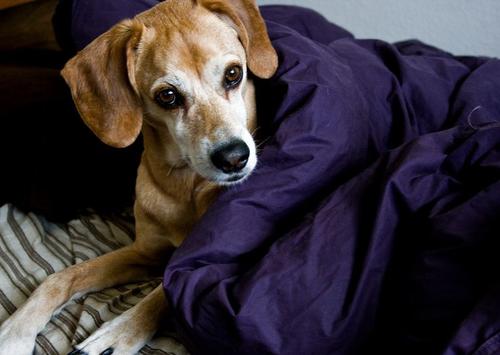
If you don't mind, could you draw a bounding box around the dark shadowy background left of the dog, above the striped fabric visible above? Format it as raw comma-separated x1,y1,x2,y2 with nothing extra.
0,0,142,220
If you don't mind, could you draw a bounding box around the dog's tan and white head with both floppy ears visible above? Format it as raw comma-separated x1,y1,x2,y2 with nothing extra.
62,0,277,184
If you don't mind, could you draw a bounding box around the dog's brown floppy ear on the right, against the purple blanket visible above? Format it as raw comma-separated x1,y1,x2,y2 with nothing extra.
200,0,278,79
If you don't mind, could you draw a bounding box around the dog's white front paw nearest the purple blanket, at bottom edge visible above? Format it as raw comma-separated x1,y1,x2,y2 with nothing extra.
68,308,156,355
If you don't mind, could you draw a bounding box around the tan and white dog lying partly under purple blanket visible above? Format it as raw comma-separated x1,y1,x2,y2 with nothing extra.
0,0,278,355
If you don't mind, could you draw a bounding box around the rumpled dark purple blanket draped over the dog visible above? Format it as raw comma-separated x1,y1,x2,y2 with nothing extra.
62,1,500,355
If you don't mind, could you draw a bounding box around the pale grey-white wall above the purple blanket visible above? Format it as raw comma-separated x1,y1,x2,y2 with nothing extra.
257,0,500,58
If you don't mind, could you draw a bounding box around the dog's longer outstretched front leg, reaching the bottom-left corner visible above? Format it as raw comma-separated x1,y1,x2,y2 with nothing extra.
0,245,156,355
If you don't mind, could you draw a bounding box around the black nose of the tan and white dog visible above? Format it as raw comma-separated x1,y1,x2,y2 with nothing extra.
210,140,250,174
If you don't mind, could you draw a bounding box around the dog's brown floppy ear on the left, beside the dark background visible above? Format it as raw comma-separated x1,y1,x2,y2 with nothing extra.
61,20,145,148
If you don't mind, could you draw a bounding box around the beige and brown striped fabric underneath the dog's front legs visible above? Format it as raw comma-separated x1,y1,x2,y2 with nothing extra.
0,205,187,355
